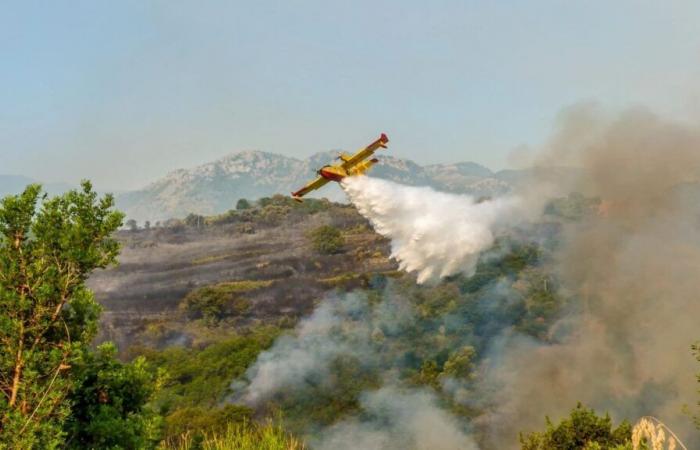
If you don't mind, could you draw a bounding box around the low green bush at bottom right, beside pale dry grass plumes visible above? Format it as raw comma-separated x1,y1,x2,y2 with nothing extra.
520,403,632,450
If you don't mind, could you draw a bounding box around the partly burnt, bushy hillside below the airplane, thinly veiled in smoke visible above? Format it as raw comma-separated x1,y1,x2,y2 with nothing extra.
91,192,640,448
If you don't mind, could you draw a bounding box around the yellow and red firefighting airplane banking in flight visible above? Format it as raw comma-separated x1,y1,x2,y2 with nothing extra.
292,133,389,202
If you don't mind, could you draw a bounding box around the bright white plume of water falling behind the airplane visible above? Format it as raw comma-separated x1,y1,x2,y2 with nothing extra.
342,176,523,283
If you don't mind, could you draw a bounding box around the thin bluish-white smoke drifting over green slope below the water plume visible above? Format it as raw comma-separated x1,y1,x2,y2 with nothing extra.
237,289,476,450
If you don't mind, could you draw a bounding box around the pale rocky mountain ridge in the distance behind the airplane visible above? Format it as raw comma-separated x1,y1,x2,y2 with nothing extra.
117,151,524,221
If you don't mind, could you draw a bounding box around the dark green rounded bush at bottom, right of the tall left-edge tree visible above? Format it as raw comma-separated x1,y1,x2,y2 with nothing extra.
64,343,163,449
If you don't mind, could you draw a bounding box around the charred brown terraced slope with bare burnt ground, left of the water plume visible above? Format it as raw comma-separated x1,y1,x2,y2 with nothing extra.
90,204,396,349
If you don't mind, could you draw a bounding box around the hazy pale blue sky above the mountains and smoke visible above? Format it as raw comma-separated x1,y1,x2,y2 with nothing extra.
0,0,700,189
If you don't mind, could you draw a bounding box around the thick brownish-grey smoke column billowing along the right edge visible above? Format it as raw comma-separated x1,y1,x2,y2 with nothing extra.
479,106,700,448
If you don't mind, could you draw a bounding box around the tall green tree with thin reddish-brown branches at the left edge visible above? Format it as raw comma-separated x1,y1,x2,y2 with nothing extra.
0,181,123,449
